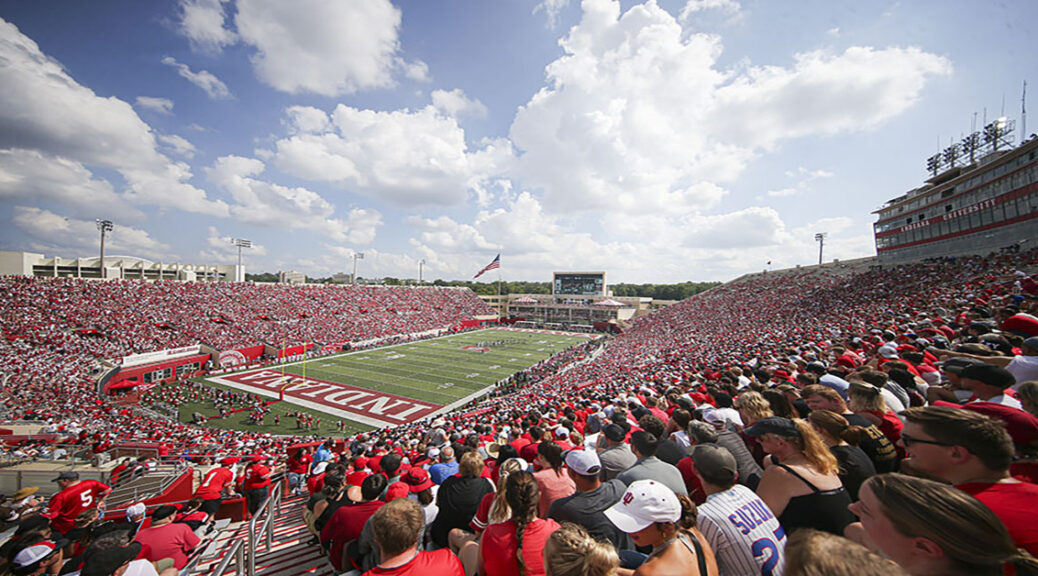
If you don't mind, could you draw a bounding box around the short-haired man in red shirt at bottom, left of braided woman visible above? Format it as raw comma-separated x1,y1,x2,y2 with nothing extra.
363,498,465,576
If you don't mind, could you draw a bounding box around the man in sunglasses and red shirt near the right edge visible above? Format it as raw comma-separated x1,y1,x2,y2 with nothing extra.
901,406,1038,555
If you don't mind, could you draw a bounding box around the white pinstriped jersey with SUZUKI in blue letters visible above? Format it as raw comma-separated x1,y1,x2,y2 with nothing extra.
698,484,786,576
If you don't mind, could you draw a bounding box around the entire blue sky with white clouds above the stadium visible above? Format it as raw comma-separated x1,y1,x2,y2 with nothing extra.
0,0,1038,282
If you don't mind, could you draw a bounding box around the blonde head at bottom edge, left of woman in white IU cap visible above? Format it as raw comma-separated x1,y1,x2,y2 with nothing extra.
544,522,620,576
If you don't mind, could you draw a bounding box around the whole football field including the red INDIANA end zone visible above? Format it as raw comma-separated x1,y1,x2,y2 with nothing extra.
208,328,596,428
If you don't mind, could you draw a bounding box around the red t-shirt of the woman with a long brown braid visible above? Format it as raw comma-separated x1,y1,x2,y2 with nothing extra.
482,518,558,576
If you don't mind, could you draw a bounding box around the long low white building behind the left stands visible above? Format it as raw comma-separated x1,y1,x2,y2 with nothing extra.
0,251,237,282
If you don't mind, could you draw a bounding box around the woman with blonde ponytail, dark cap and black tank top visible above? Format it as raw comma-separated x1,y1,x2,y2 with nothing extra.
744,416,854,536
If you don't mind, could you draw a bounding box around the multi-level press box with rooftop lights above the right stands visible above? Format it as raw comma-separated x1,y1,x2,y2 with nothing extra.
873,129,1038,264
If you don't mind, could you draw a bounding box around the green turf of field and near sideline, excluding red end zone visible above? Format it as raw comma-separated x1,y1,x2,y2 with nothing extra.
187,329,589,434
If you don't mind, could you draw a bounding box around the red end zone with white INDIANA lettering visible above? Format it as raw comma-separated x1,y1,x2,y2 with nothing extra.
213,369,442,426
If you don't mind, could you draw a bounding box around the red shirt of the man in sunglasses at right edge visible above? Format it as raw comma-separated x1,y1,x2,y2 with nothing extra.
956,482,1038,555
